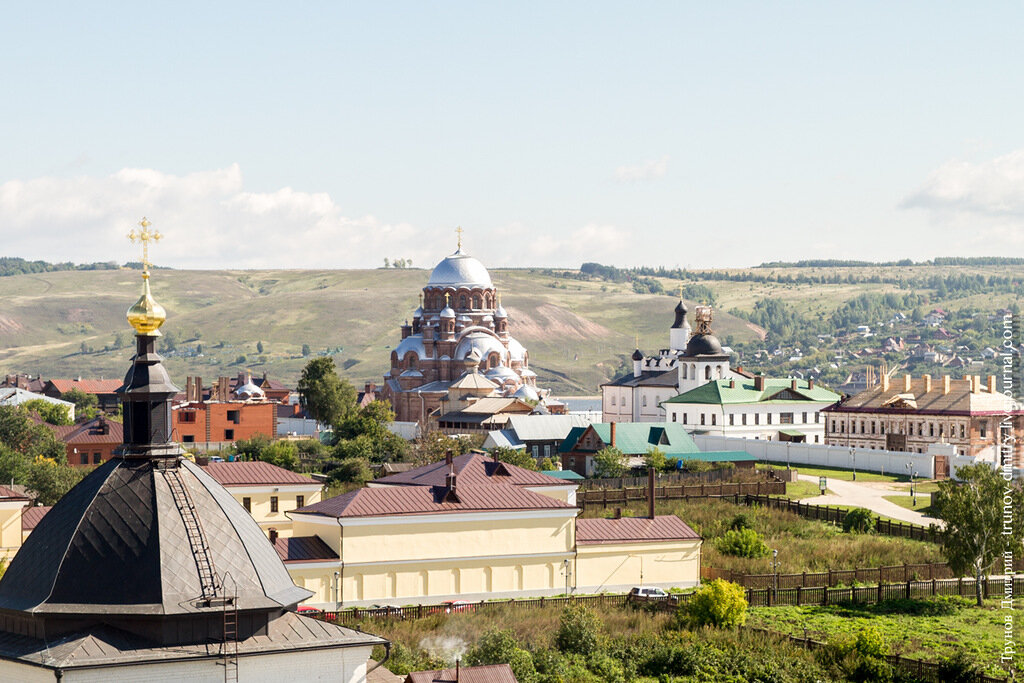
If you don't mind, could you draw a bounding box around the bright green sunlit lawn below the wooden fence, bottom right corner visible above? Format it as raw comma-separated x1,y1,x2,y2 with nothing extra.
748,597,1024,676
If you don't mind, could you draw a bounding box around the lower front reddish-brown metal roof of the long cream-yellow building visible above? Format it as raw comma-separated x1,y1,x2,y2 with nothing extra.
295,480,575,517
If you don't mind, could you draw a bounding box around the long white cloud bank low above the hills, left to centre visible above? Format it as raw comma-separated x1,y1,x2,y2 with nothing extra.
0,164,631,268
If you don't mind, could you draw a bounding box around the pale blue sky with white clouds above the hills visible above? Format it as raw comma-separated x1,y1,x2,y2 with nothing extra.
0,1,1024,268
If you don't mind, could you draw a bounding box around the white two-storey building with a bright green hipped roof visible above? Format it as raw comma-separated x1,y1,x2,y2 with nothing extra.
665,375,842,443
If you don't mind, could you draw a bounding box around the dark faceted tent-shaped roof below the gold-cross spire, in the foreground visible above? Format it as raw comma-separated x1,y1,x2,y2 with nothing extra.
0,458,310,615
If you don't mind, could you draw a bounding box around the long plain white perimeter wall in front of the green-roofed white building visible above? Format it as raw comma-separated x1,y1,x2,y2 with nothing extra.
692,434,937,479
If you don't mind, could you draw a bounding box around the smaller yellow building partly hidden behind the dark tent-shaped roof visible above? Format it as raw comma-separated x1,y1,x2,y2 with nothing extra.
203,462,324,538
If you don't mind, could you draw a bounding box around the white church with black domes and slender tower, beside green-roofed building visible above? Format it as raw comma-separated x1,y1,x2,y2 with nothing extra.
601,299,753,422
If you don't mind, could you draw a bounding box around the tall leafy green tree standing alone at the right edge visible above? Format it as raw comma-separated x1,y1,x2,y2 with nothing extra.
935,463,1024,607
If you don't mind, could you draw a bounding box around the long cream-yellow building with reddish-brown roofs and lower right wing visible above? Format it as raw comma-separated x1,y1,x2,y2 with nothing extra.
275,454,700,609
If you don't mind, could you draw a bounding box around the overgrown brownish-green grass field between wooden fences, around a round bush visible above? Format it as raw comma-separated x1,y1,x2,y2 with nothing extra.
583,499,944,573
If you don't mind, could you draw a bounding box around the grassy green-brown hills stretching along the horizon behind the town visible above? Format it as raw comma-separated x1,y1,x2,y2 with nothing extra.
0,264,1022,395
